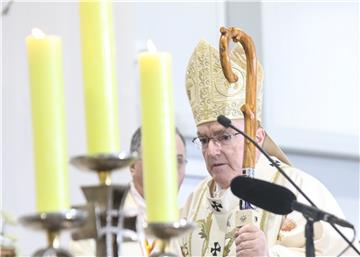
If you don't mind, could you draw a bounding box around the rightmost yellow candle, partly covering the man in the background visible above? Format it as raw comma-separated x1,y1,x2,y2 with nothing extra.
139,41,178,222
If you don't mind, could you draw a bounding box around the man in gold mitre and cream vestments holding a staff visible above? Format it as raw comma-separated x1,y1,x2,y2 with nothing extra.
180,41,356,257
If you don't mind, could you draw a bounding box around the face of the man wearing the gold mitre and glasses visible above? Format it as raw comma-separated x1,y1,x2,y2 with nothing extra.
197,120,265,188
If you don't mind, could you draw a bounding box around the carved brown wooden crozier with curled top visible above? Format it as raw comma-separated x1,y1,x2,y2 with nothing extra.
219,27,257,171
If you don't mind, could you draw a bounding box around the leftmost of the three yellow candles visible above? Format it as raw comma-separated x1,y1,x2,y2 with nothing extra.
26,29,69,212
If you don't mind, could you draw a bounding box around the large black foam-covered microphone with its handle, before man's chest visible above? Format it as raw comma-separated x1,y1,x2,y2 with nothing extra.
230,176,354,228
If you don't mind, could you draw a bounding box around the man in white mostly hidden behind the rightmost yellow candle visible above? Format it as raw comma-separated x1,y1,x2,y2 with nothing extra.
70,128,186,256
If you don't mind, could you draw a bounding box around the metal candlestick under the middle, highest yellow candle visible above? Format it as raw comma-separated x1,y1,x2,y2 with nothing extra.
71,152,137,257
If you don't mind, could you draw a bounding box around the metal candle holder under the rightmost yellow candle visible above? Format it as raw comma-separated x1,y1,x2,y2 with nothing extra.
144,219,195,257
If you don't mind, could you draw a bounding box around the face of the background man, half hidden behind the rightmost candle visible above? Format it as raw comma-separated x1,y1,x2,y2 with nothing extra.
130,135,186,196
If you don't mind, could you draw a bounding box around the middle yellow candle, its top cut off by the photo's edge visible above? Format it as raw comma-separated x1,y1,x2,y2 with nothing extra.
80,0,120,154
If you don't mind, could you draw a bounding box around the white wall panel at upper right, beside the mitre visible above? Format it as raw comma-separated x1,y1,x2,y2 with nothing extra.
261,2,360,158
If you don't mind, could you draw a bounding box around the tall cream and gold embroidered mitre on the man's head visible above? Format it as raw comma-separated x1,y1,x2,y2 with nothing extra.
186,40,263,125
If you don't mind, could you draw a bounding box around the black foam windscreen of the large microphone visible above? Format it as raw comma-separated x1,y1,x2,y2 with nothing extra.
230,176,296,215
